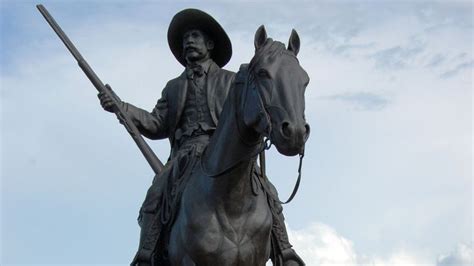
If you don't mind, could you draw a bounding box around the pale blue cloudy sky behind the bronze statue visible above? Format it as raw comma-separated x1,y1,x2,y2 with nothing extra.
0,0,474,266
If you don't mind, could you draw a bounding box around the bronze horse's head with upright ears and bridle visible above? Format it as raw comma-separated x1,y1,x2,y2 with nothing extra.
243,25,310,156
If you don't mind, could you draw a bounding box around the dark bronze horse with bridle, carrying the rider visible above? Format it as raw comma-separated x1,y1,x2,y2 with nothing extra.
168,25,309,266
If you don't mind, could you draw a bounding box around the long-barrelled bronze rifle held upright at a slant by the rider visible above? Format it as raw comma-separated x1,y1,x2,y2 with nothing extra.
36,5,163,174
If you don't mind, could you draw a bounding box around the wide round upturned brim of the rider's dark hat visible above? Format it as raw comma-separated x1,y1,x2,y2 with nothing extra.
168,8,232,67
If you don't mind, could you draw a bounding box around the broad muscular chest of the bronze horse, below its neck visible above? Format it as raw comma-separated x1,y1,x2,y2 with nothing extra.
171,186,272,265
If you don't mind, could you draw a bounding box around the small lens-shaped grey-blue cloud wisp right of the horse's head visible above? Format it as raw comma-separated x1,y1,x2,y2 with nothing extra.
325,92,390,111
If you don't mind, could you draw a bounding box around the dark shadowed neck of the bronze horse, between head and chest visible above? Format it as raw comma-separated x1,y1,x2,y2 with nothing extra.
203,69,261,204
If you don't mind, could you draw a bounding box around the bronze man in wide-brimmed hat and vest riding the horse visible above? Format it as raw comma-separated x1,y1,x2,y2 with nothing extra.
99,9,304,265
